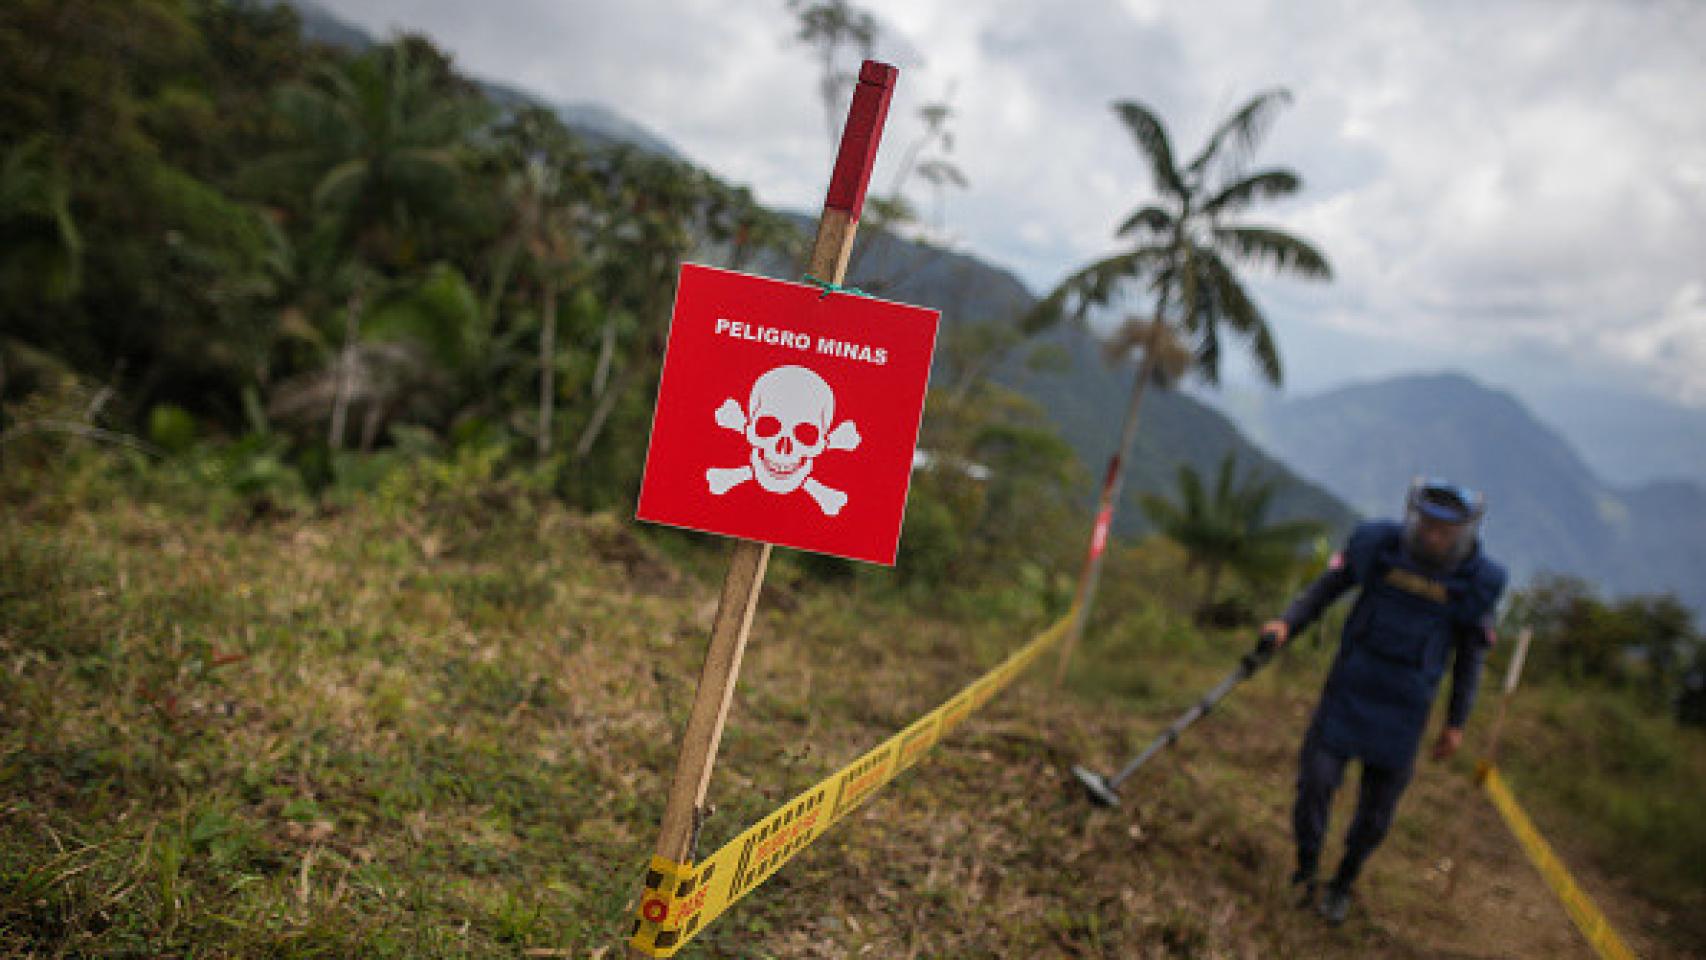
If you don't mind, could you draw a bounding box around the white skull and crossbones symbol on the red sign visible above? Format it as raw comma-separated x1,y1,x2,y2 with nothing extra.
705,367,860,517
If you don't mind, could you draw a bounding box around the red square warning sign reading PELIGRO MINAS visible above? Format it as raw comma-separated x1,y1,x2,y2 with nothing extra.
638,264,938,564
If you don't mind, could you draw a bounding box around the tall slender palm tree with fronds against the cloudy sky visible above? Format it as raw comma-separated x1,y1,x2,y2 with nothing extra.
1025,89,1332,677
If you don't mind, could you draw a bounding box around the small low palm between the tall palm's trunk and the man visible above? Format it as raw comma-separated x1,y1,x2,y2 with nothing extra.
1143,454,1320,612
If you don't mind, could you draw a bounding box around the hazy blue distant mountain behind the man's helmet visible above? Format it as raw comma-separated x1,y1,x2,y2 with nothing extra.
1242,373,1706,610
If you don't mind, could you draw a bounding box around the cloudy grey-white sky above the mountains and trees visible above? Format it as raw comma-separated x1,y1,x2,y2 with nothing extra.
321,0,1706,453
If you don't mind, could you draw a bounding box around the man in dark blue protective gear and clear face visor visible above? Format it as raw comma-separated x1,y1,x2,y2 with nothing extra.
1262,479,1506,926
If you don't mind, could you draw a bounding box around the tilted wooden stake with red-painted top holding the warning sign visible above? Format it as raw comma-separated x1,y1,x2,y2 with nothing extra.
628,60,899,957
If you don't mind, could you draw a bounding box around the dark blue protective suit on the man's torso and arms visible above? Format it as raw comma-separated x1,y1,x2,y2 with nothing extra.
1285,522,1506,771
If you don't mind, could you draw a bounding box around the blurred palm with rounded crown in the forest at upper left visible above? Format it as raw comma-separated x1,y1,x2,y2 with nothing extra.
264,43,479,448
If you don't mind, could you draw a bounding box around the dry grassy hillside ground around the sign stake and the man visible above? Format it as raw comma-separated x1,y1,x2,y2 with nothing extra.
0,460,1706,957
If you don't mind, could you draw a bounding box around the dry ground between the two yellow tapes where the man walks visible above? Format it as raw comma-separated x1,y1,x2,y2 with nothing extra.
710,668,1686,960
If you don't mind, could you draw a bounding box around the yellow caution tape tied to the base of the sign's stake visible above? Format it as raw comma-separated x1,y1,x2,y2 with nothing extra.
628,612,1073,957
